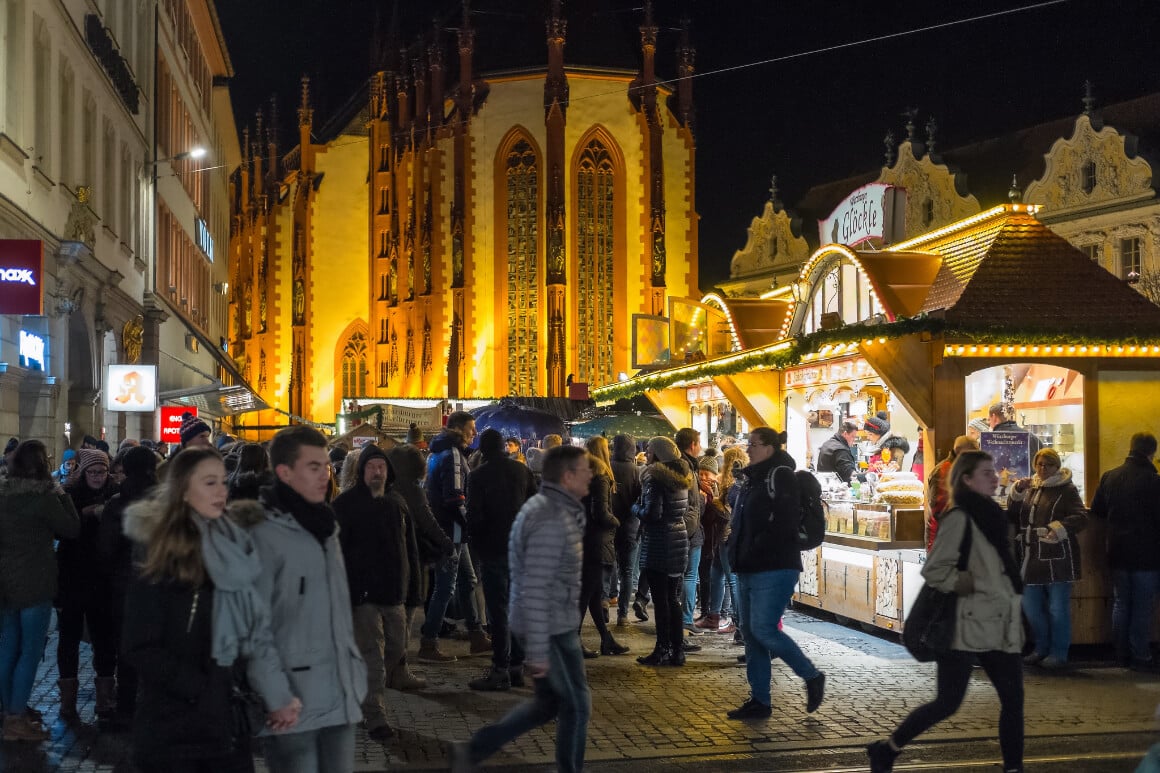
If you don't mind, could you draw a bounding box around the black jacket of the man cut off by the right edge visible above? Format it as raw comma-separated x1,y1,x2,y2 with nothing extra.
1090,454,1160,571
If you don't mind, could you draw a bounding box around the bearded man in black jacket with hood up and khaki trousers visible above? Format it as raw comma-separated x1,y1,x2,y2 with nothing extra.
334,446,420,742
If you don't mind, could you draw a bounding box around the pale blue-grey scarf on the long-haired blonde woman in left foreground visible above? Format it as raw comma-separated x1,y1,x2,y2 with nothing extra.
194,508,270,667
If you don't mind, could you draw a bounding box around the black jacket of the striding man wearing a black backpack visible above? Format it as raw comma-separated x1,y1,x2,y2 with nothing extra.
728,449,802,575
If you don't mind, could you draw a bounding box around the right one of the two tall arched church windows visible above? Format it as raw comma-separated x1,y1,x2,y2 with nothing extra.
577,139,615,384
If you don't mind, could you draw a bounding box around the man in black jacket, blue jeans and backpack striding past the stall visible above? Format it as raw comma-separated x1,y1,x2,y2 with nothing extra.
727,427,826,720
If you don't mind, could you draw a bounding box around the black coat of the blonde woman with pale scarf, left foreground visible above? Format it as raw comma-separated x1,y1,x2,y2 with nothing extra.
122,579,238,766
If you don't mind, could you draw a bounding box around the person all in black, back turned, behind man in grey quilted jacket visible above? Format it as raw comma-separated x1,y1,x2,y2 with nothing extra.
467,429,536,691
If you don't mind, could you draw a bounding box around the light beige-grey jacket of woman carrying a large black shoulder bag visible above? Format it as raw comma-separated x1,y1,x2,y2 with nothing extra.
922,507,1023,652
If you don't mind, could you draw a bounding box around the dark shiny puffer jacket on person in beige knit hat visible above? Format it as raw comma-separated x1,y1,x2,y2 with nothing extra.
636,460,695,577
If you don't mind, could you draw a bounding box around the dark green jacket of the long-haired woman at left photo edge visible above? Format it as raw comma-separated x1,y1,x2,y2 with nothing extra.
0,477,80,609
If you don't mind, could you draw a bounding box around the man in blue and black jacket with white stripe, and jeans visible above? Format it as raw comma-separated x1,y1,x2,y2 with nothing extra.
419,411,492,663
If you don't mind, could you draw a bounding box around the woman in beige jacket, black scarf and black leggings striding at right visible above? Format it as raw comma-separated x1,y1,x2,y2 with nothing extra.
867,451,1023,773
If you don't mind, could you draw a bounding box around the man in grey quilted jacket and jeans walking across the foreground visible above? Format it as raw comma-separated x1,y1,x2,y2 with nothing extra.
451,446,592,773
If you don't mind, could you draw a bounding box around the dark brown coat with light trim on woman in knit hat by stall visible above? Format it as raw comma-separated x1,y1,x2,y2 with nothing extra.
1007,469,1087,585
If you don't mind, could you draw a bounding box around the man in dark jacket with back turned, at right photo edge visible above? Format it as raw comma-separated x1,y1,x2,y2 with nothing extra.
1090,432,1160,671
